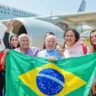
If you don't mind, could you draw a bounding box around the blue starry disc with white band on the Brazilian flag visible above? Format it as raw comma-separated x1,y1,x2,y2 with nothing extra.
36,68,65,96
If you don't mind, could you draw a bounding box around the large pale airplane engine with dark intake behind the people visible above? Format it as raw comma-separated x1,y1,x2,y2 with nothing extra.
12,18,64,48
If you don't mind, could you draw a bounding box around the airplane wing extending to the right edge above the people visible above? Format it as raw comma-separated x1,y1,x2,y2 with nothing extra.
36,12,96,29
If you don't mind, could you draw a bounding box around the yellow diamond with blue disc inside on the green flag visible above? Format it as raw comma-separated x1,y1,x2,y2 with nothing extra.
18,63,86,96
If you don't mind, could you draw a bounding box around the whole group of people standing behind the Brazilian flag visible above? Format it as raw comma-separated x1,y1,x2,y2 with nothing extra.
0,22,96,96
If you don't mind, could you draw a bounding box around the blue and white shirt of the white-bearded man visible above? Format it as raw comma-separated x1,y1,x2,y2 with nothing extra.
37,49,64,60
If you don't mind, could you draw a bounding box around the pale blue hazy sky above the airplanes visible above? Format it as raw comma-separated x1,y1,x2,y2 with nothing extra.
0,0,96,15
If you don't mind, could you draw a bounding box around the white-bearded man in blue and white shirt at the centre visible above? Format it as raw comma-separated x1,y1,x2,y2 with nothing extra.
38,35,64,60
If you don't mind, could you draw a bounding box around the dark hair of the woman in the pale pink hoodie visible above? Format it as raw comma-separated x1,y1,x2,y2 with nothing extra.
63,28,80,48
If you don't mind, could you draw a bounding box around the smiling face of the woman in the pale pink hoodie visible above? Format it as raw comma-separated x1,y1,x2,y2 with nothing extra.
64,30,76,47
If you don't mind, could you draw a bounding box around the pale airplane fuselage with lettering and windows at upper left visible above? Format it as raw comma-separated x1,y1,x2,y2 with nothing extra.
0,4,38,20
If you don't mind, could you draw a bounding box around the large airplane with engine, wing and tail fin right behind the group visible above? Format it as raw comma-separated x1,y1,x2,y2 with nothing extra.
0,0,96,51
